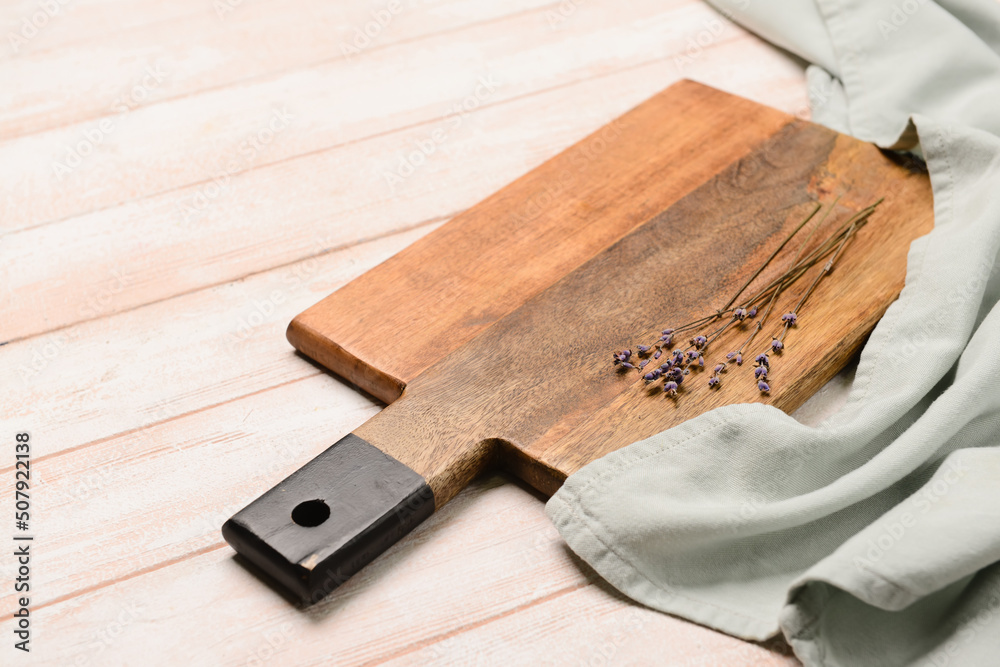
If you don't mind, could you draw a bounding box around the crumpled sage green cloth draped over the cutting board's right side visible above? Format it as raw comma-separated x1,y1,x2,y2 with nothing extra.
547,0,1000,667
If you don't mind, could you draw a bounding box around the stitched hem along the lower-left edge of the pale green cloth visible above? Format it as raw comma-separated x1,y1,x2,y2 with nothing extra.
545,496,781,641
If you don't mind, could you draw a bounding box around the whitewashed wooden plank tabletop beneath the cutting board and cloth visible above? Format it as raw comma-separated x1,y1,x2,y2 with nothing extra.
0,0,844,666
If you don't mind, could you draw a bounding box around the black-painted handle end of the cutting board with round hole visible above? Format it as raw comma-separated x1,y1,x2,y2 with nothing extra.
222,433,434,604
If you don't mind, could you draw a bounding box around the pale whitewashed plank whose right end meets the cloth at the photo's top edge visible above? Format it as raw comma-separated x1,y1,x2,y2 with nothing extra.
0,0,712,237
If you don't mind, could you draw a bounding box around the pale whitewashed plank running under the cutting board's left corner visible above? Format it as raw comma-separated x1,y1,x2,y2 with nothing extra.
0,223,440,460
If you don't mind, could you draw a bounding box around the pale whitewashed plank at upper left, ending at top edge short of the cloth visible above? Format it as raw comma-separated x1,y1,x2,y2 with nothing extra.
0,0,551,139
